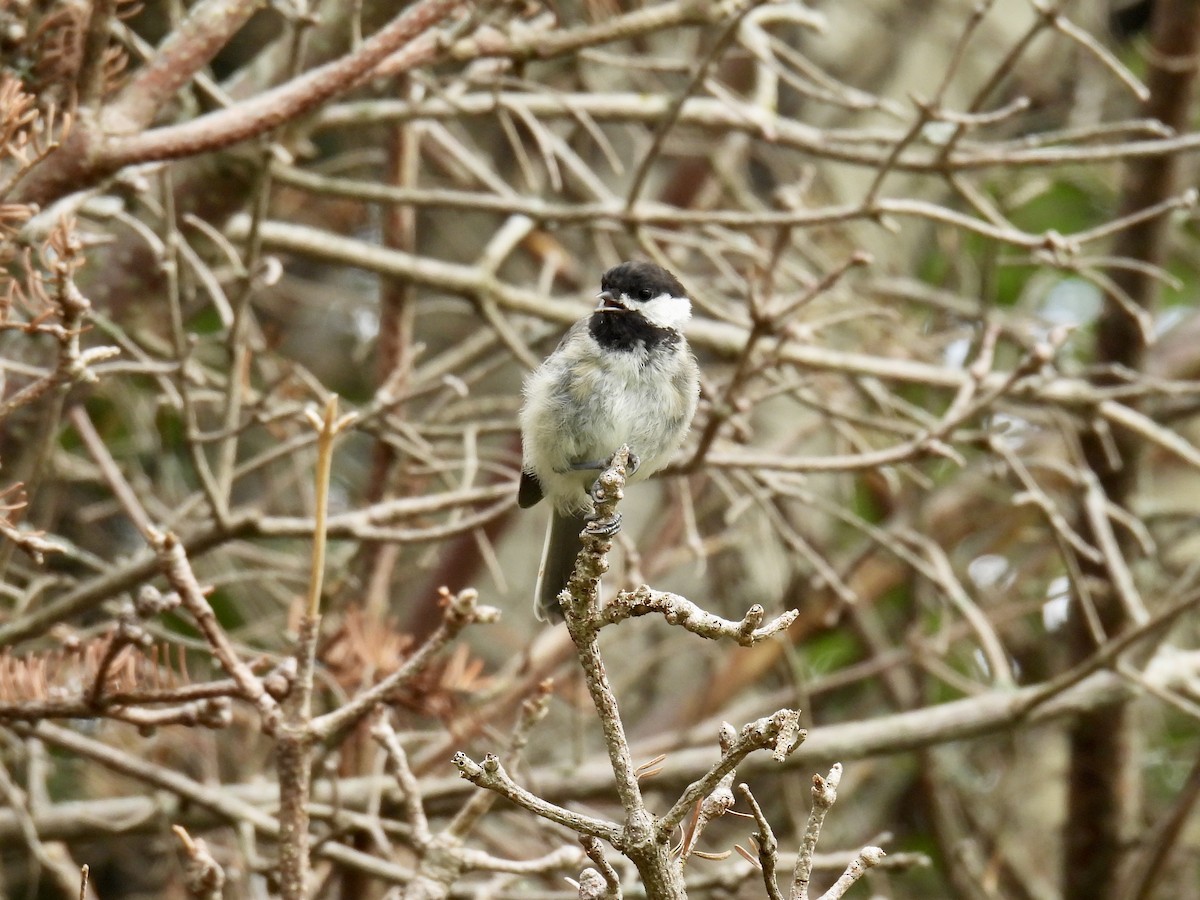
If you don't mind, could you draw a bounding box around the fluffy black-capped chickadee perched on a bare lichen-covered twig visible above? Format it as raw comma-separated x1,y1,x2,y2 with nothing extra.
517,263,700,622
